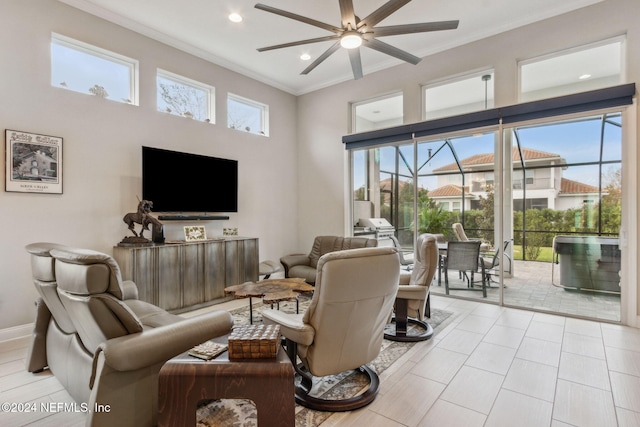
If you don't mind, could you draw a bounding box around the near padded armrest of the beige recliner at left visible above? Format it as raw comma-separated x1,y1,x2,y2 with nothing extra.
91,310,233,378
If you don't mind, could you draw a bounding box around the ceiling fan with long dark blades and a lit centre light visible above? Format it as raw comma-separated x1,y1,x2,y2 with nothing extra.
255,0,459,80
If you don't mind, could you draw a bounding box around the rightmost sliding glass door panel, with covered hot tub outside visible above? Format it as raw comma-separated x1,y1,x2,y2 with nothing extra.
504,113,622,321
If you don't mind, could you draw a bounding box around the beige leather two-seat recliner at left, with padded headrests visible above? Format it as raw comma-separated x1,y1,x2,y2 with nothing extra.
27,243,233,427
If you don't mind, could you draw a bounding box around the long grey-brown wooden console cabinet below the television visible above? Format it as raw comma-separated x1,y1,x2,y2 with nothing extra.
113,237,259,312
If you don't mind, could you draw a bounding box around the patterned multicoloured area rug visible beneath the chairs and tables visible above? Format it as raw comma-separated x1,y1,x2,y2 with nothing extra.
196,296,451,427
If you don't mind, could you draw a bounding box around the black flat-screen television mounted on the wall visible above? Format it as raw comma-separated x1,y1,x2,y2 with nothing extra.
142,146,238,214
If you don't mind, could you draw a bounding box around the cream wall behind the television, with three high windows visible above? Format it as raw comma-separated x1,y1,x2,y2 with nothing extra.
0,0,297,330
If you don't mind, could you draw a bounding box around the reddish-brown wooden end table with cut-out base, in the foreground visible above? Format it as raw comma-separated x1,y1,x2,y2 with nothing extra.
158,336,295,427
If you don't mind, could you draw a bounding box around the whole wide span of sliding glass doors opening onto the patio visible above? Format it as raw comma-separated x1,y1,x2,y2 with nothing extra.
351,112,622,321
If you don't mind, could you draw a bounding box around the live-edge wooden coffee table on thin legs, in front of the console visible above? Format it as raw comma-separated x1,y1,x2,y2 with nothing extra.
224,278,315,324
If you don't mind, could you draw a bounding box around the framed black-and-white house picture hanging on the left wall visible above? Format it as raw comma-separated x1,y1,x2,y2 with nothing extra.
4,129,62,194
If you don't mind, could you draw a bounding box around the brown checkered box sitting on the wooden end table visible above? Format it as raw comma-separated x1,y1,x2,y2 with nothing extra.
229,325,280,359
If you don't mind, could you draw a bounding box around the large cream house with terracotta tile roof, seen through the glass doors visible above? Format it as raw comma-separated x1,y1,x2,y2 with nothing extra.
429,148,599,211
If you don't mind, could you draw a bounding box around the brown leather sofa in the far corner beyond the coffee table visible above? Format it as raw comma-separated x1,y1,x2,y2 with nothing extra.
280,236,378,284
